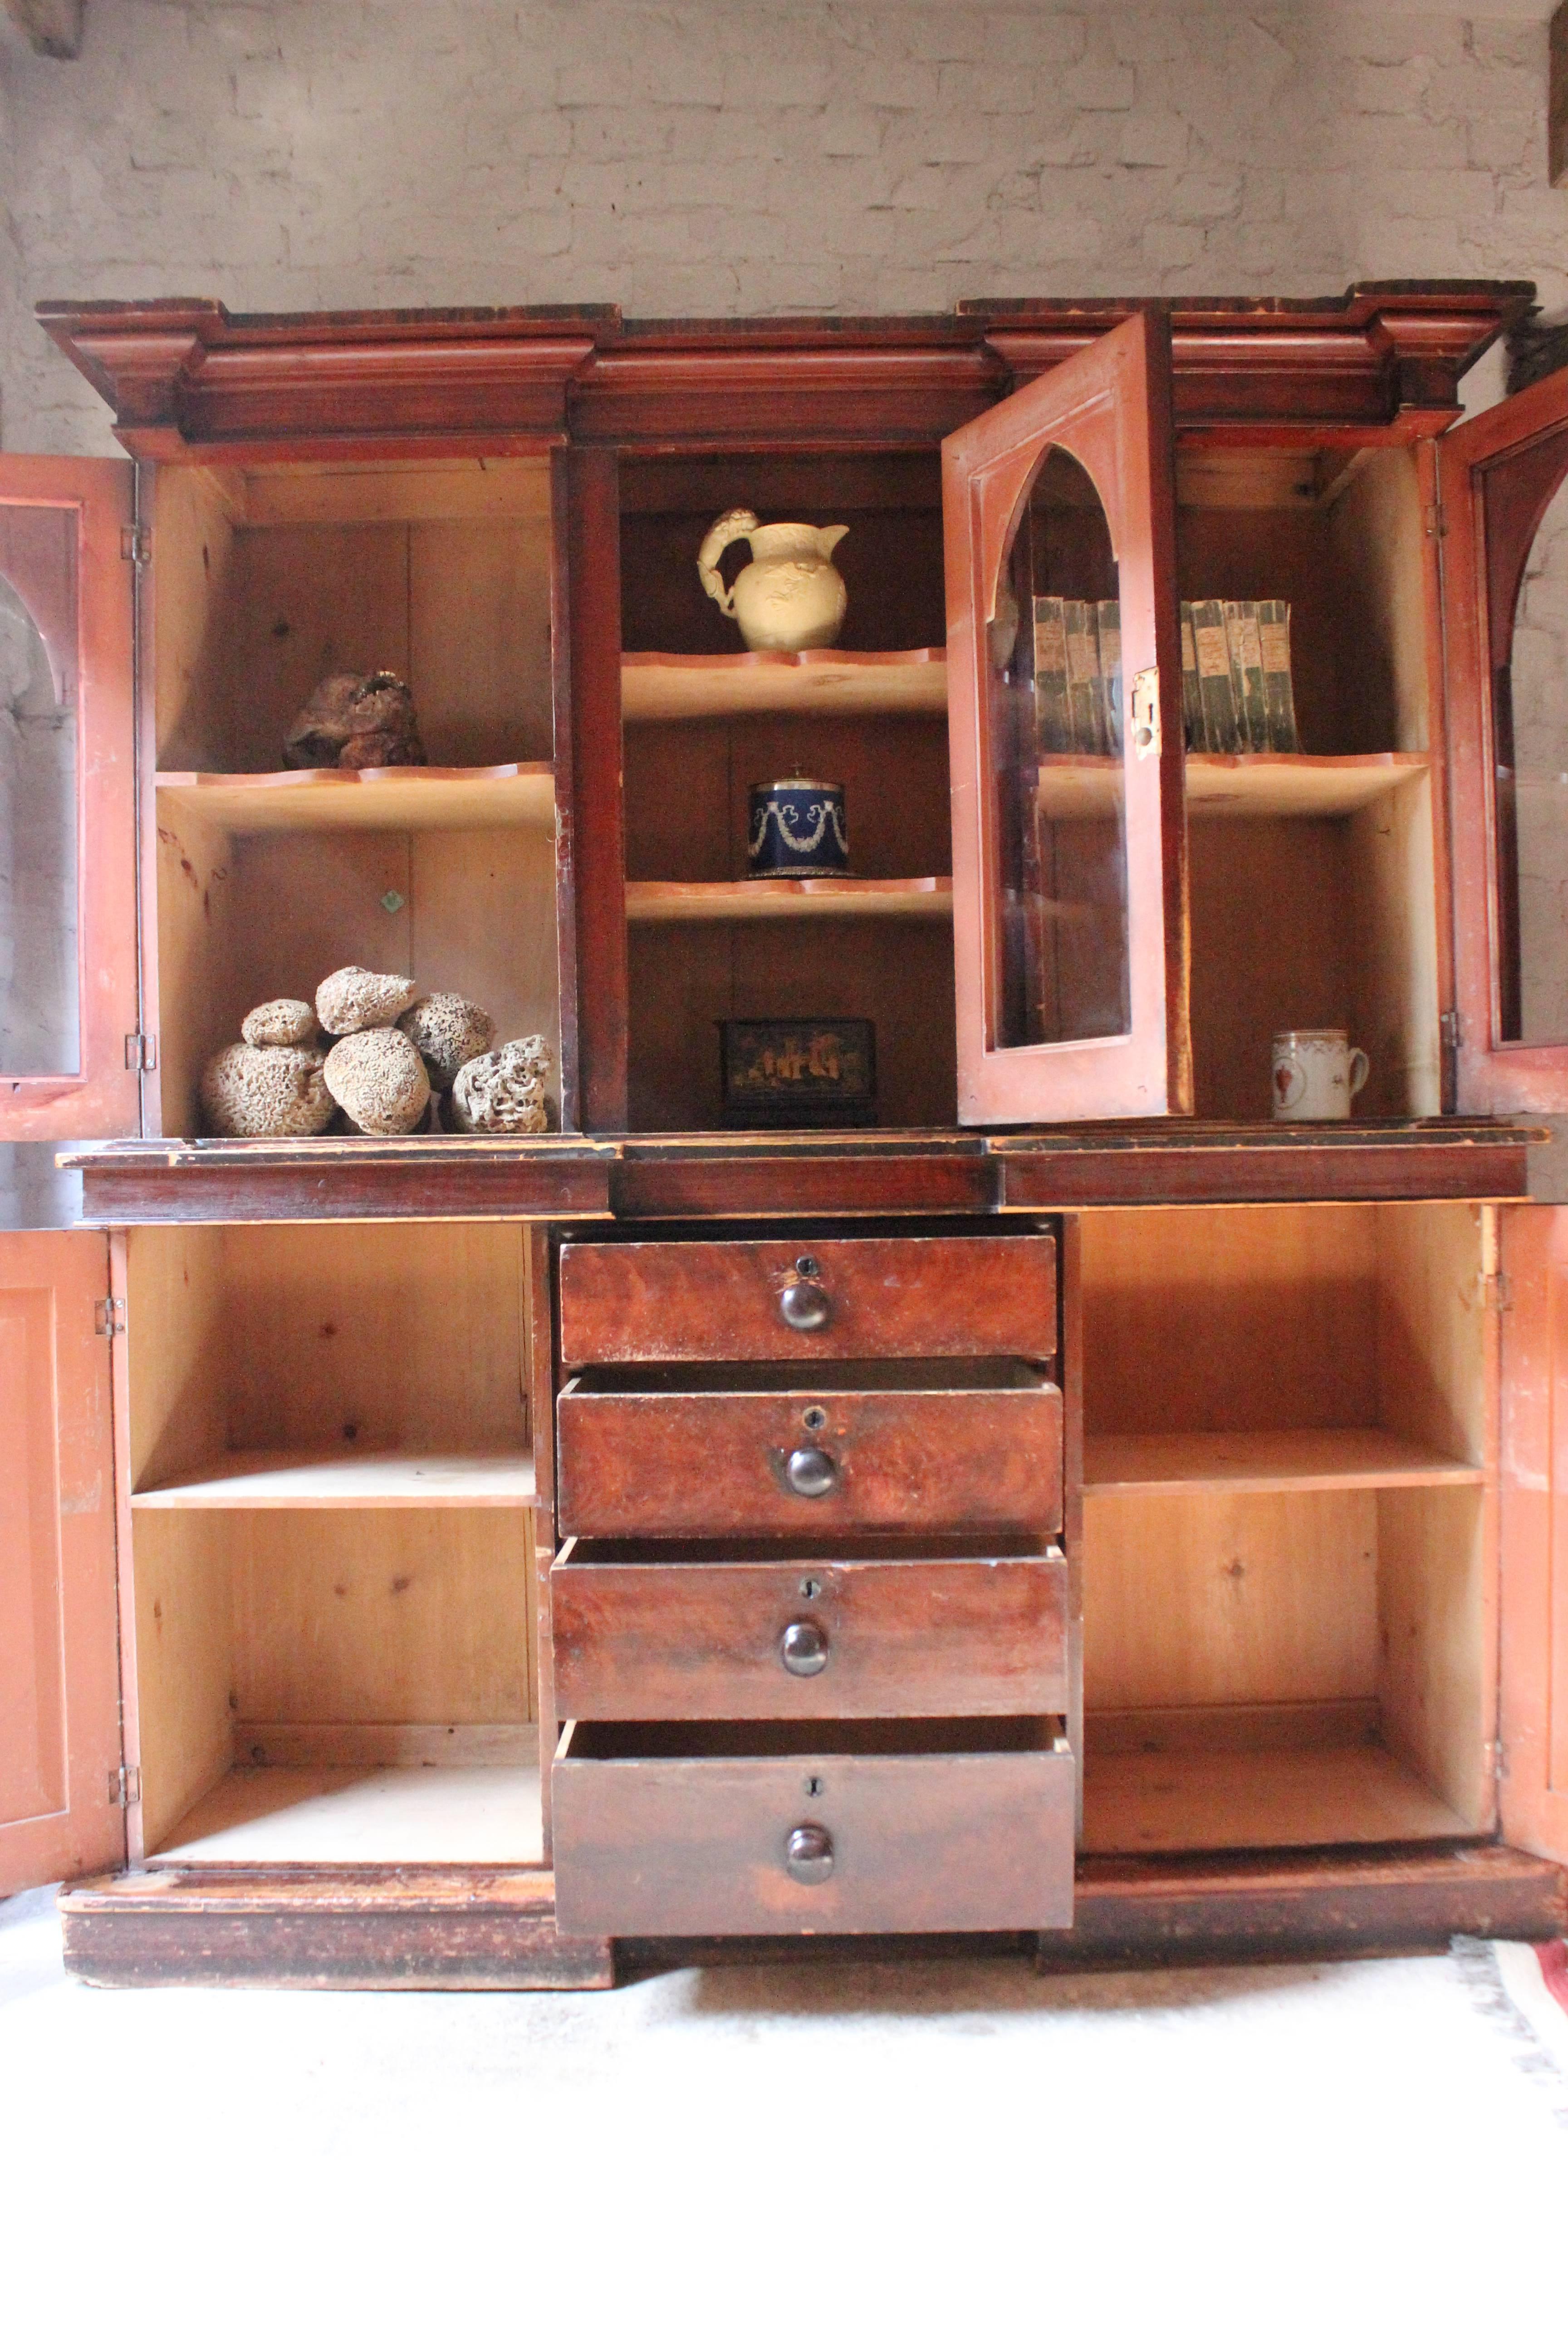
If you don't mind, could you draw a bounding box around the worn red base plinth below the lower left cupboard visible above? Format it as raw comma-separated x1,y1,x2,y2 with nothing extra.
59,1865,616,1992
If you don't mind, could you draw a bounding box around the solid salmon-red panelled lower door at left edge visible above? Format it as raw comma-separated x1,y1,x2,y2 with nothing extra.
0,1232,125,1896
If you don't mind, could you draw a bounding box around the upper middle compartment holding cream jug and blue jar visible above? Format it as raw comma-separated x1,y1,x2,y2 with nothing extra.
618,451,955,1129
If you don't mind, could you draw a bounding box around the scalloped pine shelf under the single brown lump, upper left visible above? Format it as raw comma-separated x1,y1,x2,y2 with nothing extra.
157,760,555,833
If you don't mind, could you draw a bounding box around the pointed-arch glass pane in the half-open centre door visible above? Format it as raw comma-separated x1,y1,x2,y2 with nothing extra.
990,449,1131,1047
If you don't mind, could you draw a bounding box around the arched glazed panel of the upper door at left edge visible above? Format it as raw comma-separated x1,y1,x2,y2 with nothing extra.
0,508,82,1077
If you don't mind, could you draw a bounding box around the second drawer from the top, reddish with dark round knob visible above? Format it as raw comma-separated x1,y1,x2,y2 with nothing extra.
555,1364,1063,1548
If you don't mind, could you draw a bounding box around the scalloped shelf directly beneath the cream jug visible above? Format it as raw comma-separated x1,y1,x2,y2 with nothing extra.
621,644,947,720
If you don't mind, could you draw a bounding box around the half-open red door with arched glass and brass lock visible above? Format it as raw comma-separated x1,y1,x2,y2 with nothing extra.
943,313,1192,1124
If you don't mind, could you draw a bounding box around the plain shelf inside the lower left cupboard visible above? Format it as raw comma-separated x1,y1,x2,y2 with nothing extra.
132,1446,536,1510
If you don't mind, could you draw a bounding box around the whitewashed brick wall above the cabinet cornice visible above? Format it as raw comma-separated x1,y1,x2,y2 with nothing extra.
0,0,1568,451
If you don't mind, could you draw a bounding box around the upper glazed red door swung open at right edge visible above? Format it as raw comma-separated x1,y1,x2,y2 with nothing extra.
1436,369,1568,1112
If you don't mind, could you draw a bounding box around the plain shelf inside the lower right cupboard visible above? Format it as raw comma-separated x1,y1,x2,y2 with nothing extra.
1084,1430,1483,1496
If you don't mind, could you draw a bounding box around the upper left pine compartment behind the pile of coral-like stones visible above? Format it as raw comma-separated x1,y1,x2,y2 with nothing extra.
153,456,573,1136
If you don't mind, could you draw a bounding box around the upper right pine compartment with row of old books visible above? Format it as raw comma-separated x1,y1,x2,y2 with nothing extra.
1176,445,1443,1122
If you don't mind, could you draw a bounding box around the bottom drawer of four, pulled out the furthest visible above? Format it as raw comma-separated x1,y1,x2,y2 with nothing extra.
553,1720,1074,1936
